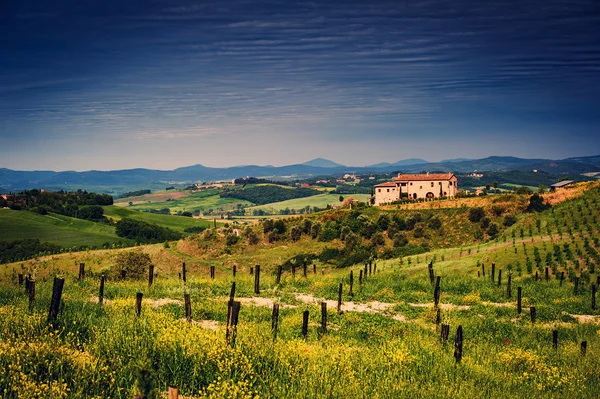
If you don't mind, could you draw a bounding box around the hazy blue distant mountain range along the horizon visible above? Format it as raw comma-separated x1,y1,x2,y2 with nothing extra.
0,155,600,193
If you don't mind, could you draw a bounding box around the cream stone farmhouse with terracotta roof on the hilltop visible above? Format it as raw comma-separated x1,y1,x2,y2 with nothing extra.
374,173,458,205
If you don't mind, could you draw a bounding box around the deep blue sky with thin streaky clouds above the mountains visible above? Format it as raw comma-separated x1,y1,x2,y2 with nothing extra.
0,0,600,170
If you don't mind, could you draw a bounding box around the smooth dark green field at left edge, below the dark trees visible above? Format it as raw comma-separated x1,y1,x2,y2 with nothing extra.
0,209,129,248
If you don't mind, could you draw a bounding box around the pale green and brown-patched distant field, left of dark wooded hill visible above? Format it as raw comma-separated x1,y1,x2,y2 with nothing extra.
115,190,252,216
